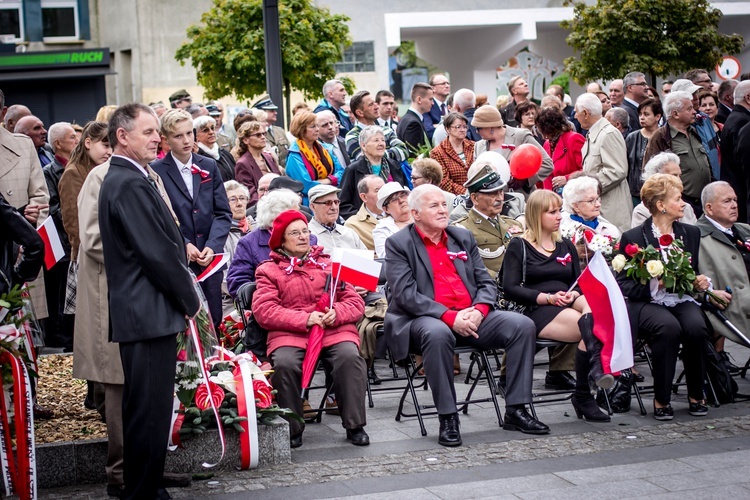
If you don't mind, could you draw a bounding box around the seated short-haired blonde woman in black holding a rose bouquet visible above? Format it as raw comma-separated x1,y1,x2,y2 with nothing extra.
612,174,709,420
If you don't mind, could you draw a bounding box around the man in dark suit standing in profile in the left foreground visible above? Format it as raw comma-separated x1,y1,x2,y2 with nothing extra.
99,104,200,500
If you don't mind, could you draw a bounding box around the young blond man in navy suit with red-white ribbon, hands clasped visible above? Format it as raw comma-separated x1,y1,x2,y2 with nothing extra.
151,109,232,325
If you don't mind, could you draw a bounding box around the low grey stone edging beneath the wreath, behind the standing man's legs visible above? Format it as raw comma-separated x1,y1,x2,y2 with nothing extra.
36,418,292,488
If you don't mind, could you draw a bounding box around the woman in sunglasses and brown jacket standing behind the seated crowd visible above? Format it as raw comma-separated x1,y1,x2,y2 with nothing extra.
234,121,281,206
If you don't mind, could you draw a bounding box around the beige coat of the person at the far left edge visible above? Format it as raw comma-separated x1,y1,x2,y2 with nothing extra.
0,127,49,319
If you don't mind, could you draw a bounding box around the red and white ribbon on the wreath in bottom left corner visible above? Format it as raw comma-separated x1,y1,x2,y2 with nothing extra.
0,351,37,500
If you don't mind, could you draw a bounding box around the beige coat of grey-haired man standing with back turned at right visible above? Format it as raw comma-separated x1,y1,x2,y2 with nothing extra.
581,118,633,232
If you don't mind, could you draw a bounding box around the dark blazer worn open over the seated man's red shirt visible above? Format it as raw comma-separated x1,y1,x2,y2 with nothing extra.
384,224,497,360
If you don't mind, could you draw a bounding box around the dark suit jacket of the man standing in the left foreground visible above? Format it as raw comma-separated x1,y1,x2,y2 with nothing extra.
99,156,200,342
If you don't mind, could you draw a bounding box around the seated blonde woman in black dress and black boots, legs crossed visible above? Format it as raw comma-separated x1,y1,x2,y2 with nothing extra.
503,190,614,422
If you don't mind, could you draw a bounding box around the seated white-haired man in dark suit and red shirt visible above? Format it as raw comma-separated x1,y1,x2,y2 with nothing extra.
385,184,549,446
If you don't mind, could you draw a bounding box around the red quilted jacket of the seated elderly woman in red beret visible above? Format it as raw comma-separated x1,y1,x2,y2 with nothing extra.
253,252,365,354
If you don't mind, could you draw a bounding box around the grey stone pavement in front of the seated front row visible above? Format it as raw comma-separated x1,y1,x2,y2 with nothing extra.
40,346,750,500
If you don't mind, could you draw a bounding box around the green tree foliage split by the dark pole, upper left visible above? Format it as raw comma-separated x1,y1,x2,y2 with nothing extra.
175,0,352,119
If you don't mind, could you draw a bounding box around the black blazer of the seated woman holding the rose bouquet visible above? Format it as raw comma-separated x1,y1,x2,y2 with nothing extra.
617,217,701,338
